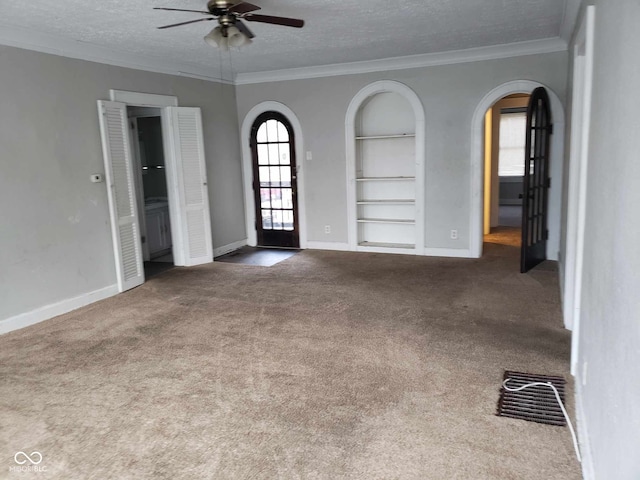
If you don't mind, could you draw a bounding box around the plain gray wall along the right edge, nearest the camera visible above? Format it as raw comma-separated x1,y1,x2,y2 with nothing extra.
564,0,640,480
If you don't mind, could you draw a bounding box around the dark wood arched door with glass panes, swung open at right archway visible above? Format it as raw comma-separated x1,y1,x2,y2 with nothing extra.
520,87,553,273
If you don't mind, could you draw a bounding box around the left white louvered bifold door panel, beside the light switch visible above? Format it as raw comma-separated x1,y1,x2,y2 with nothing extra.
98,100,144,292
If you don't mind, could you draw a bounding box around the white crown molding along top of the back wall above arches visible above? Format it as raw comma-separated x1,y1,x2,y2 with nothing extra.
235,37,567,85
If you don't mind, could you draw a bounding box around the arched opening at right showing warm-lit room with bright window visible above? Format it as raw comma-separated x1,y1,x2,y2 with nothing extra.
483,93,531,248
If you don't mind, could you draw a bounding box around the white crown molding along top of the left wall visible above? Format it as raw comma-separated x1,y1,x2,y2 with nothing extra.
0,25,233,84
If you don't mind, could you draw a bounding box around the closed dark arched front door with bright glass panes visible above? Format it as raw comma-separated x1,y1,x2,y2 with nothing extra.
250,112,300,248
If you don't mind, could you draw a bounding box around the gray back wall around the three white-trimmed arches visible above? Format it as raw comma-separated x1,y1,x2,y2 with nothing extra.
237,52,567,249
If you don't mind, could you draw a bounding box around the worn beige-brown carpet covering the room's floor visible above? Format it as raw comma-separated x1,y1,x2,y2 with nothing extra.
0,244,580,480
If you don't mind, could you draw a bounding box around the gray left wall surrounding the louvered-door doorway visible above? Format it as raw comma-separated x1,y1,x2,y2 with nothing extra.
0,46,246,320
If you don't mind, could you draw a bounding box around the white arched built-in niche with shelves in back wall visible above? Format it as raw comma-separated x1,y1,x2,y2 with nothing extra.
346,81,424,255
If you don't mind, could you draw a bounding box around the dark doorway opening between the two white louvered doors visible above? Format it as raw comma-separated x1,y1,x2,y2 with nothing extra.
127,107,175,278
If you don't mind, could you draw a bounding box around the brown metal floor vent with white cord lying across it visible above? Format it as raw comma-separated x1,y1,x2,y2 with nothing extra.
497,371,567,427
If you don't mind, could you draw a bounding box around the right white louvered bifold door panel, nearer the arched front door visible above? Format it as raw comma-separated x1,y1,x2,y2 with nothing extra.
167,107,213,266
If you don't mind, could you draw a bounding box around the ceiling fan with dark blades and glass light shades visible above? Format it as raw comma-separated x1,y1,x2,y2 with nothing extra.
154,0,304,48
